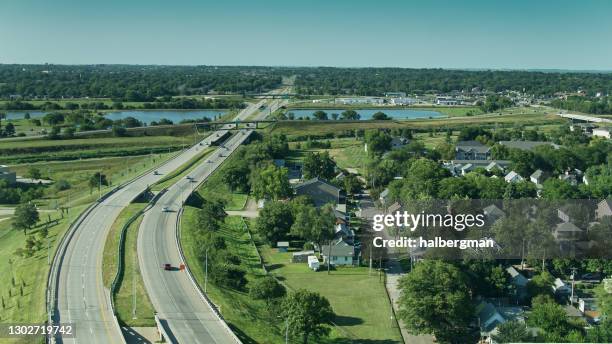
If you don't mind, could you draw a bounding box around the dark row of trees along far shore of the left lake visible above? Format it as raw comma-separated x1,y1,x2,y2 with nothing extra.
0,96,244,111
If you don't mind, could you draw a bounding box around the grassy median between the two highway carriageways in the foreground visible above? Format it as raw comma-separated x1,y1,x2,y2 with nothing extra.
102,203,155,327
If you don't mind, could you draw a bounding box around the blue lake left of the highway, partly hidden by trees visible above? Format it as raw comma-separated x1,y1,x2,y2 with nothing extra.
6,110,227,124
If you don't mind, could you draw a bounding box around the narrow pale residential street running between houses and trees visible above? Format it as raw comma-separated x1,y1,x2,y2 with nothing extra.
360,196,434,344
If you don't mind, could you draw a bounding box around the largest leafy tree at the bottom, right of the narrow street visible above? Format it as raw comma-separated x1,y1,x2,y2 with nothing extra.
399,260,474,343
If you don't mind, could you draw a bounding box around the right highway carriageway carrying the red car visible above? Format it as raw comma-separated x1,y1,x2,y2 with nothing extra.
138,93,285,344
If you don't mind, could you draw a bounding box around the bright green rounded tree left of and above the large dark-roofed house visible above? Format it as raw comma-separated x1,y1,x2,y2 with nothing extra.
251,164,291,200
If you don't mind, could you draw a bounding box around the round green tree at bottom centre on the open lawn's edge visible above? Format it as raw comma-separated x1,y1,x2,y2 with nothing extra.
283,289,335,344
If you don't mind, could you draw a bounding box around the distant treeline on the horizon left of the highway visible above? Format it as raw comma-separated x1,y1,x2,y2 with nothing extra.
0,65,282,102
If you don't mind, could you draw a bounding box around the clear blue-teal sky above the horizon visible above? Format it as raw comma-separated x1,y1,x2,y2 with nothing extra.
0,0,612,70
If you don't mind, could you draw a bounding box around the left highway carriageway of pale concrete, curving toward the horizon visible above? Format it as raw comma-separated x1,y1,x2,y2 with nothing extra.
48,90,284,343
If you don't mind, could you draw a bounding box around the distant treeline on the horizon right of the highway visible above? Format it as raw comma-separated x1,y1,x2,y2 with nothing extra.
295,67,612,96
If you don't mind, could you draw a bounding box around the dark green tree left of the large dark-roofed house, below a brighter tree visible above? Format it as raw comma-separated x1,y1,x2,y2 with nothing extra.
255,201,293,245
